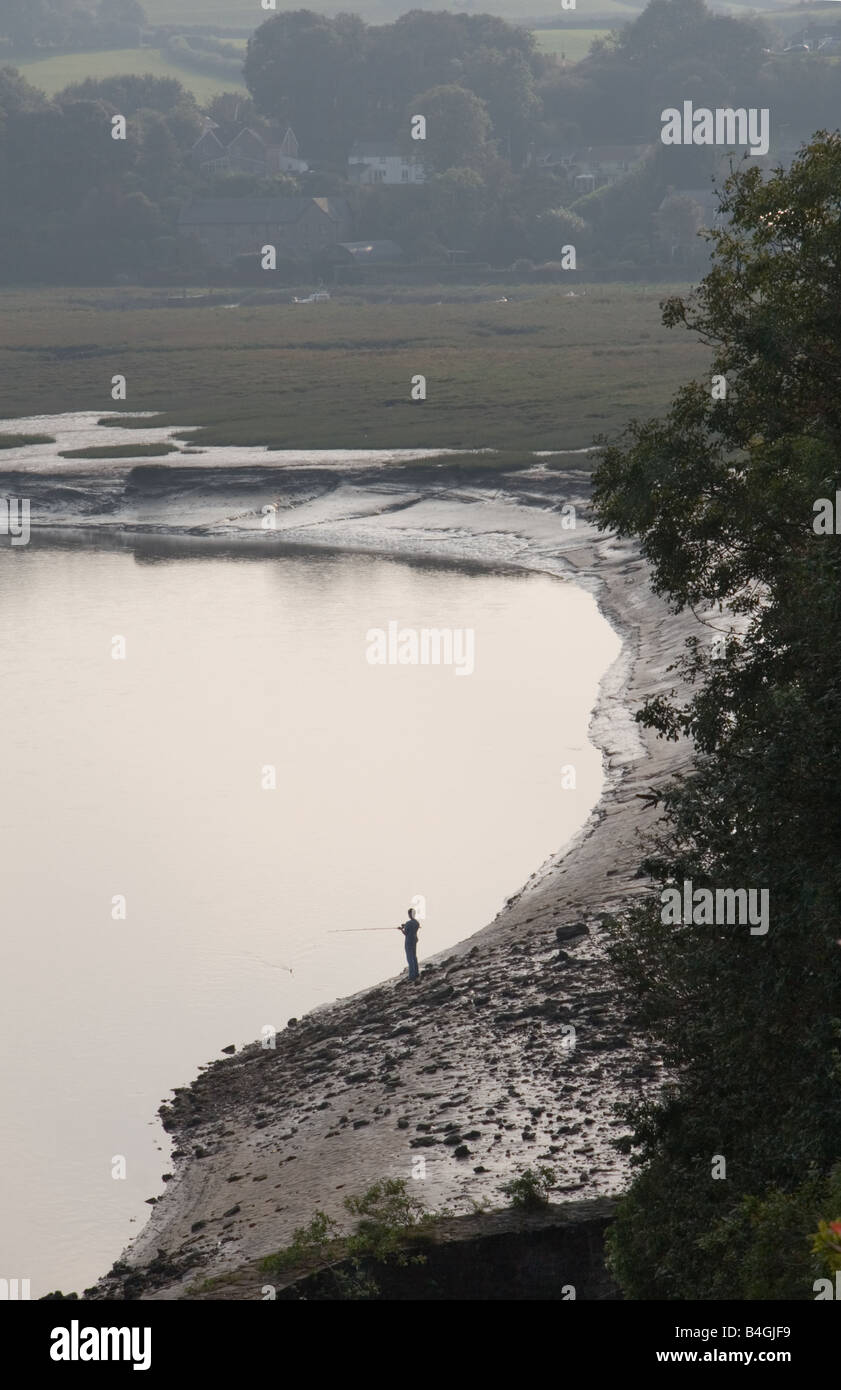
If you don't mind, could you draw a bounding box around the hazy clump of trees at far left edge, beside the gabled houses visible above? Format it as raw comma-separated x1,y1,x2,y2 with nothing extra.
0,68,202,282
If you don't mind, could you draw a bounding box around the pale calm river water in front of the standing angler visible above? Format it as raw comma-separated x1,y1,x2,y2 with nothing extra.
0,537,620,1297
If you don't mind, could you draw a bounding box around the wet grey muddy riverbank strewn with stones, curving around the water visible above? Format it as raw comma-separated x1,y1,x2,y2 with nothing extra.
9,447,688,1298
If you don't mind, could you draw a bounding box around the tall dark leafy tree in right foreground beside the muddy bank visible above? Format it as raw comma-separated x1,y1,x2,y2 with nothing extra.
594,133,841,1298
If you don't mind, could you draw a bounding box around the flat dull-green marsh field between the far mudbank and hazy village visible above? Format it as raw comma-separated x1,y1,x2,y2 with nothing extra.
0,285,708,449
